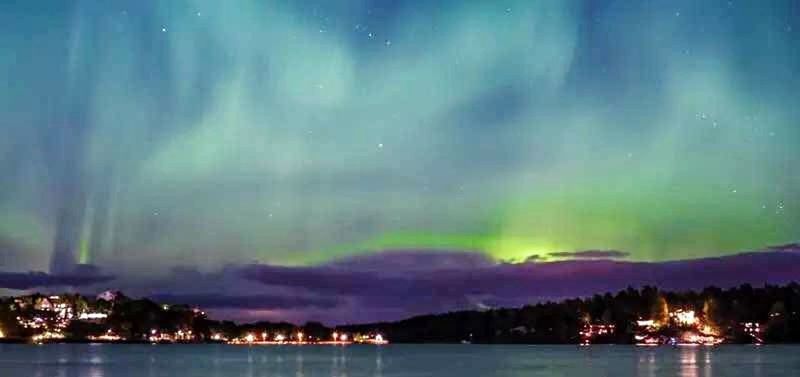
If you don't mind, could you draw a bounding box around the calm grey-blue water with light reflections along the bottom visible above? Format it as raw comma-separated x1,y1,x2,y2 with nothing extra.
0,344,800,377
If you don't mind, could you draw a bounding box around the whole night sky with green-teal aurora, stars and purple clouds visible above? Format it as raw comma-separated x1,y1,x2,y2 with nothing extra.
0,0,800,323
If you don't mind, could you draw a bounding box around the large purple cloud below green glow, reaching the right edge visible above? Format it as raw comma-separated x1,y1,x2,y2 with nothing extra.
228,245,800,322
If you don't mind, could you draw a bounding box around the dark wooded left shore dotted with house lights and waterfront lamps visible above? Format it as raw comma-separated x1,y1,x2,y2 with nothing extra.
0,291,388,345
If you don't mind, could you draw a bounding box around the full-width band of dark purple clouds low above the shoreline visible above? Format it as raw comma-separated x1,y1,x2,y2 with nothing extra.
0,244,800,323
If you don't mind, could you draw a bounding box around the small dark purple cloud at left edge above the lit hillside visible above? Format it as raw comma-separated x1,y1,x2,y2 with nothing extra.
0,265,114,290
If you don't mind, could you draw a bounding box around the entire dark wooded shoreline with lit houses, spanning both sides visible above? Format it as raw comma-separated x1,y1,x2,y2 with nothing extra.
0,283,800,346
